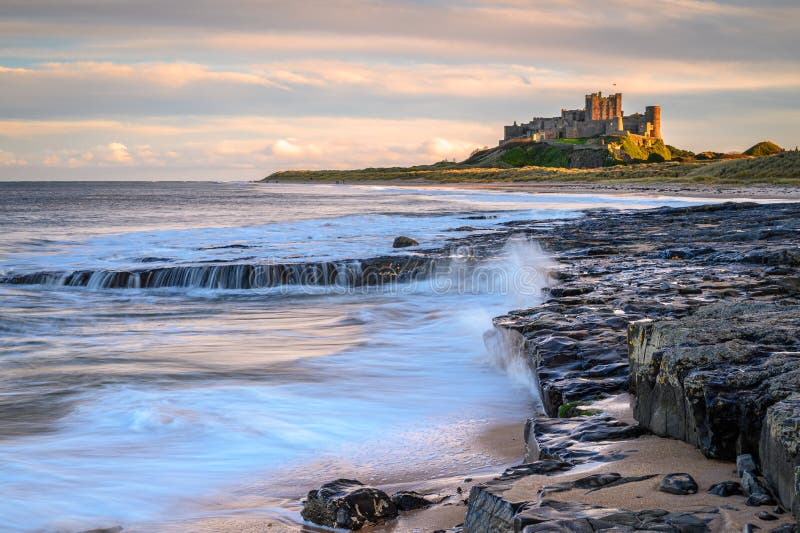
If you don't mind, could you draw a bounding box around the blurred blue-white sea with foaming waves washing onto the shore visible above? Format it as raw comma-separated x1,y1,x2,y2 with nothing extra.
0,182,706,531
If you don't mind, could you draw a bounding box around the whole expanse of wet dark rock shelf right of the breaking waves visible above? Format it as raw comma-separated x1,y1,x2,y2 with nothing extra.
464,204,800,532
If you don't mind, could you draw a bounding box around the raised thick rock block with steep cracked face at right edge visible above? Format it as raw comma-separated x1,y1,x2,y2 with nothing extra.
628,303,800,513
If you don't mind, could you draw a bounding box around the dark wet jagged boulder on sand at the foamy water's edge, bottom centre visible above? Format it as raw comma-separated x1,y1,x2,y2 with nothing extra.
300,479,397,530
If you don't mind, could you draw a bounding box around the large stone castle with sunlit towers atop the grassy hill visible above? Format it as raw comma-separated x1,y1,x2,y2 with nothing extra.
500,92,661,144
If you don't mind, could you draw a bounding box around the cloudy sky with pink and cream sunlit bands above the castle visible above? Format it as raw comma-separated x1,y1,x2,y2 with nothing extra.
0,0,800,180
